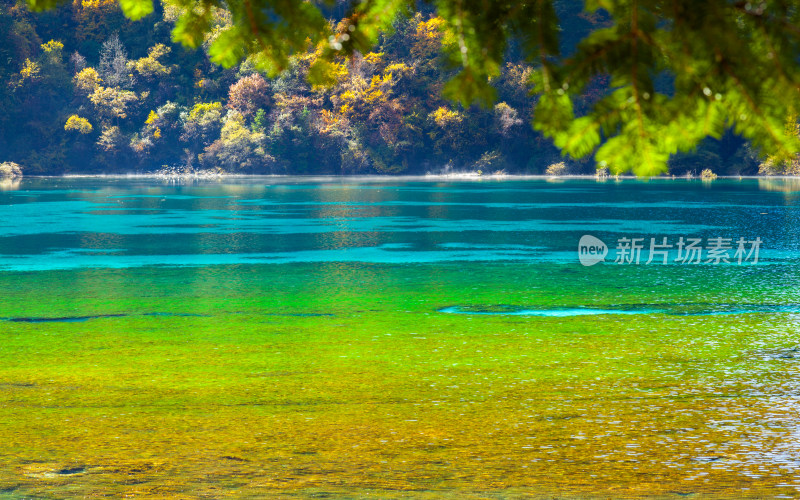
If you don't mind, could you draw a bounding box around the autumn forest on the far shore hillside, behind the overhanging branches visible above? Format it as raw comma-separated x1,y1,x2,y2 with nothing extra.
0,0,780,175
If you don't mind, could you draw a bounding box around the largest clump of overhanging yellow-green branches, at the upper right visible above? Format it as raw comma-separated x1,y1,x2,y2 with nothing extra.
534,1,800,176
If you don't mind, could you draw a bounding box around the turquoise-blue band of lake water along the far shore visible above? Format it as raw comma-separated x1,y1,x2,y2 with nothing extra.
0,178,800,271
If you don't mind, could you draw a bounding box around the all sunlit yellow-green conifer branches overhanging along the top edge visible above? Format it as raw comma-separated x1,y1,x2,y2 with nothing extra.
23,0,800,175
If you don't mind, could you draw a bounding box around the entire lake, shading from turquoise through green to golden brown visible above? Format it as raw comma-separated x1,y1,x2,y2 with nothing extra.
0,177,800,499
